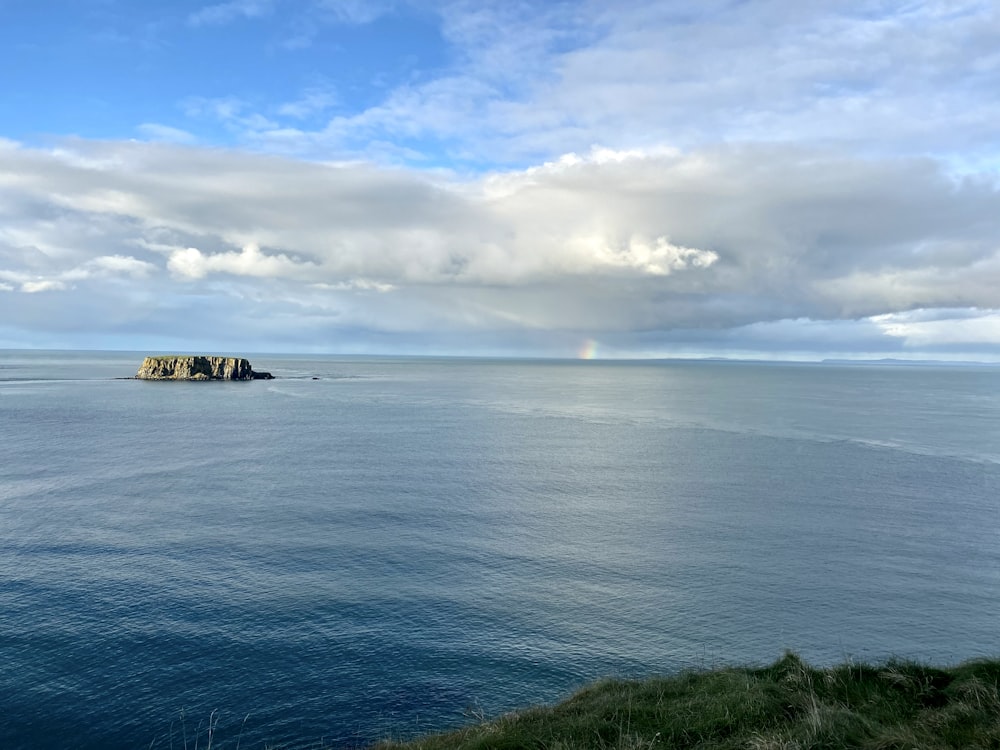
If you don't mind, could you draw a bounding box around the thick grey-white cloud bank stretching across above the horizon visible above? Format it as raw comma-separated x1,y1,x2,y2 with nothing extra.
0,141,1000,352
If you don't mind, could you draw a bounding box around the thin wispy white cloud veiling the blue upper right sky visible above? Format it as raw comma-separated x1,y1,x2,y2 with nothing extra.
199,0,1000,167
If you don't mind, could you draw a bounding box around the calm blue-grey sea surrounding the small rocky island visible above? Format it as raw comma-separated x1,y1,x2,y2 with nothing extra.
0,351,1000,750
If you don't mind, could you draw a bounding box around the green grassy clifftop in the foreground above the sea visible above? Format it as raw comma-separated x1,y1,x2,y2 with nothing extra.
378,653,1000,750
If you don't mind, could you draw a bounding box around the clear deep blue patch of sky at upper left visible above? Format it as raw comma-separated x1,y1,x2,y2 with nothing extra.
0,2,448,150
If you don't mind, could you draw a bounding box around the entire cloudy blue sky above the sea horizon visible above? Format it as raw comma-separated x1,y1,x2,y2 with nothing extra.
0,0,1000,362
